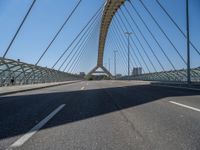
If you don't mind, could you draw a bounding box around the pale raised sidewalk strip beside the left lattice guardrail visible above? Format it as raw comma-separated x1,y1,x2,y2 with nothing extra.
0,80,81,96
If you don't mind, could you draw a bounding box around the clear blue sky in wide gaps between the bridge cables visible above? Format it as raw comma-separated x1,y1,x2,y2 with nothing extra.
0,0,200,73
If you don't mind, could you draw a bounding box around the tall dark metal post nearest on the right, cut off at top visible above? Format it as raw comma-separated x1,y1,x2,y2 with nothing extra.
186,0,191,85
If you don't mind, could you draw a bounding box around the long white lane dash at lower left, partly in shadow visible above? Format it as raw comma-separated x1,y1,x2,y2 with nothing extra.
10,104,65,148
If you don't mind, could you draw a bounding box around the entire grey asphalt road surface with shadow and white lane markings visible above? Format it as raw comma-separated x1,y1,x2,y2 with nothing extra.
0,81,200,150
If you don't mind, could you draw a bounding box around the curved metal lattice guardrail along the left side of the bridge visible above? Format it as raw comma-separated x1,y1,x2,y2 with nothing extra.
0,57,81,86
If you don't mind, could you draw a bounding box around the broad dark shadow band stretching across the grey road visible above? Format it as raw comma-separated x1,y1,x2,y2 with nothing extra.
0,85,200,141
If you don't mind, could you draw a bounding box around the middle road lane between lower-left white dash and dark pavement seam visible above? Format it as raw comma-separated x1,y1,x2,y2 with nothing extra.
15,83,150,150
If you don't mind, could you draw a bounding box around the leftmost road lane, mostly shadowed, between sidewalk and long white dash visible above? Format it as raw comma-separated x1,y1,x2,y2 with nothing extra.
0,83,84,149
